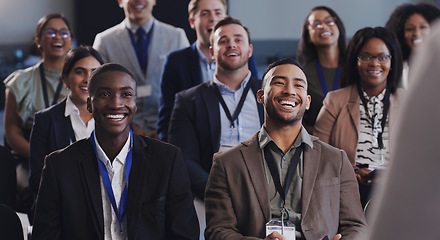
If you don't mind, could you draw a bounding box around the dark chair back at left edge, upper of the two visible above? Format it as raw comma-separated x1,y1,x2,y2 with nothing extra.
0,146,17,209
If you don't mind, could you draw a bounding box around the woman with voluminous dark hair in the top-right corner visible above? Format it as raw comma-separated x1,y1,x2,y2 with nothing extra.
385,3,440,88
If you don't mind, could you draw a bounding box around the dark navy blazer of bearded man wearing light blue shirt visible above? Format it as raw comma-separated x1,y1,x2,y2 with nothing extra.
168,77,264,199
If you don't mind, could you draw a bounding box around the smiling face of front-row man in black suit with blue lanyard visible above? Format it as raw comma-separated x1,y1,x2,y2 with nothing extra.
87,71,137,137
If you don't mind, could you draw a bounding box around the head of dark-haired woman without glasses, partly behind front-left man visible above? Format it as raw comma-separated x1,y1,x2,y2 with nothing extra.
63,56,101,106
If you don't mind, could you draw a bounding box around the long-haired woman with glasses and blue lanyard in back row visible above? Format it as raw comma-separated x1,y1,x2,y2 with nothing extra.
297,6,347,134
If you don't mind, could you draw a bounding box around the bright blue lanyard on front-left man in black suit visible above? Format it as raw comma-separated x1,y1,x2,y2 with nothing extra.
90,129,133,232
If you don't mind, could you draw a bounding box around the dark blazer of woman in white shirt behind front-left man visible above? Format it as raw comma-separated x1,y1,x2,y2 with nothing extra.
29,98,75,194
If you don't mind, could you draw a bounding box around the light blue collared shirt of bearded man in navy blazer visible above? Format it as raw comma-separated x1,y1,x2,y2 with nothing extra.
213,71,261,151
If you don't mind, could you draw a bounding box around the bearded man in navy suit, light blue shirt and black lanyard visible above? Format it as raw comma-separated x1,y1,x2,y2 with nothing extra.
168,17,263,200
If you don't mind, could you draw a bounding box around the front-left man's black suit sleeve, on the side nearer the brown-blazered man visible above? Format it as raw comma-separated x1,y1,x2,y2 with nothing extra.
165,148,200,240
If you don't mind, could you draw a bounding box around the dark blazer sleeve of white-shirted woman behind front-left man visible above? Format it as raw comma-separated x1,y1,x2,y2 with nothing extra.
29,113,52,194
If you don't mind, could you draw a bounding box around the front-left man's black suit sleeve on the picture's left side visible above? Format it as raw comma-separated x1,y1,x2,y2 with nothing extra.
32,156,61,240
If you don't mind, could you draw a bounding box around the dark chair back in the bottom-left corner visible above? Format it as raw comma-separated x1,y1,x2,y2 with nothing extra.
0,204,24,240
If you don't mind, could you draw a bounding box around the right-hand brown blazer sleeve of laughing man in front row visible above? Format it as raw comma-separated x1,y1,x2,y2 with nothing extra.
332,150,366,239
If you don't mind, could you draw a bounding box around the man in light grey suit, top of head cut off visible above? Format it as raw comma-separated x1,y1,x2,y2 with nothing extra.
93,0,189,137
